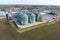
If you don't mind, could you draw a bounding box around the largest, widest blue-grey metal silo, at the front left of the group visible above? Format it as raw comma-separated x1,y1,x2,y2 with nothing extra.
17,13,28,25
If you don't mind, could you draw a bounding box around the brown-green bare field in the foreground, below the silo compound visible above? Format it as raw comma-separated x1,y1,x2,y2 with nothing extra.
0,19,60,40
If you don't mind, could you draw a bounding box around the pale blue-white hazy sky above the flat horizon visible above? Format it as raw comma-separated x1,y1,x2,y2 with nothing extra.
0,0,60,5
